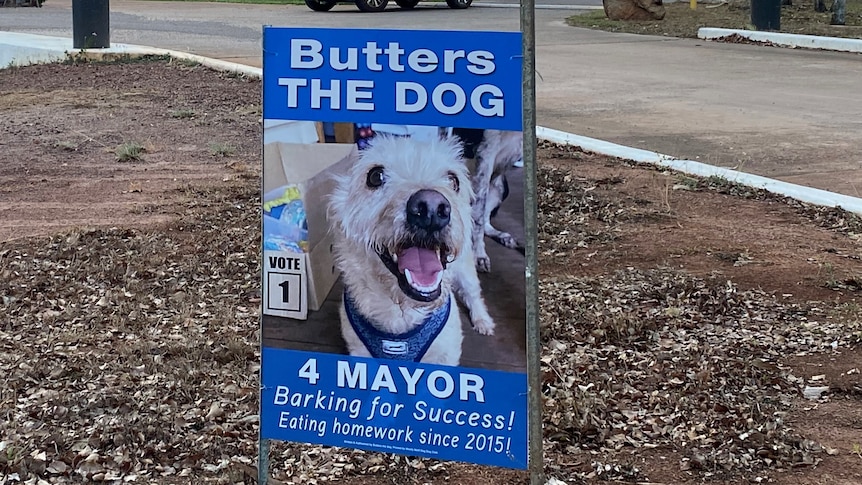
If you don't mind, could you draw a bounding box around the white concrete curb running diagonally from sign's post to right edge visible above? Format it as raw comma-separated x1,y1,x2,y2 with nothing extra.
536,126,862,214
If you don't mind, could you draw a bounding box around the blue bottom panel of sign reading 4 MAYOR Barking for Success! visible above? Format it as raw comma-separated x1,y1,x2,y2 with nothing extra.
261,347,527,469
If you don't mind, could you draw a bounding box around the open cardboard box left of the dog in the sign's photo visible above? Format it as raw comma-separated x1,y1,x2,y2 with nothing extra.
263,143,358,320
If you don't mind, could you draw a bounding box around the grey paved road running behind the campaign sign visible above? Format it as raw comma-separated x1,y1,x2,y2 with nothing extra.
5,0,862,197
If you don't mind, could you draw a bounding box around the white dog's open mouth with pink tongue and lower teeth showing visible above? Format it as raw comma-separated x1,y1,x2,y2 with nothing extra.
378,245,456,301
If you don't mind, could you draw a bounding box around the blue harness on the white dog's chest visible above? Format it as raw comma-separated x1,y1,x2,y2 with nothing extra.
344,288,452,362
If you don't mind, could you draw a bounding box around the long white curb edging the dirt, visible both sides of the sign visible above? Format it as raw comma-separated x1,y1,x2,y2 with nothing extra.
5,32,862,214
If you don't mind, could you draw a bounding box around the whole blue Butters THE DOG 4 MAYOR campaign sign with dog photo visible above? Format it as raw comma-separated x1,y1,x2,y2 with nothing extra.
261,27,528,469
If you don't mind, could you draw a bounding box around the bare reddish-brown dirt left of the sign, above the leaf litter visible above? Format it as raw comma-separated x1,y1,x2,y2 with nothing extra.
0,57,260,241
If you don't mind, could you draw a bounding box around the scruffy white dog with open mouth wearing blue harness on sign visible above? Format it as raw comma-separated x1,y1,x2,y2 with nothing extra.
329,136,494,365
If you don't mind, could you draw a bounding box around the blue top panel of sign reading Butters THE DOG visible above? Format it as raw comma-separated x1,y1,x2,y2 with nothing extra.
263,27,522,131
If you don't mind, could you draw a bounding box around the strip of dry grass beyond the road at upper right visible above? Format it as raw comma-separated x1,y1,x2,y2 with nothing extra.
566,0,862,39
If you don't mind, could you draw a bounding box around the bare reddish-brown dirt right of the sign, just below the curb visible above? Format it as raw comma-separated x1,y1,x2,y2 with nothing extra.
545,154,860,301
